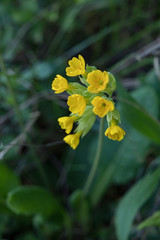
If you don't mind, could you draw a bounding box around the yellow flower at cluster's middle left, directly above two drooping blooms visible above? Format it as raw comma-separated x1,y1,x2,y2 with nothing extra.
67,94,86,116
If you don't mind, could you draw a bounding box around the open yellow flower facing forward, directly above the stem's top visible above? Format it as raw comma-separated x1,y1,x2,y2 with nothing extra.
91,96,114,118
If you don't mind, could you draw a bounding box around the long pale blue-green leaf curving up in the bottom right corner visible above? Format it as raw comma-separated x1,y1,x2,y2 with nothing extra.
115,164,160,240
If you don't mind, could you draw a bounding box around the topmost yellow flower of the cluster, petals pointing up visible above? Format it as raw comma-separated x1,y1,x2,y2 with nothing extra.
66,55,85,77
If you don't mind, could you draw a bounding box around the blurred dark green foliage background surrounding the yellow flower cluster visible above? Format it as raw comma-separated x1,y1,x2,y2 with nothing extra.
0,0,160,240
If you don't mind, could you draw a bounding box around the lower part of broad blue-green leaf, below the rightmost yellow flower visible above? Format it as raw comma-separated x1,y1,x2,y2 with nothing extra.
113,129,151,184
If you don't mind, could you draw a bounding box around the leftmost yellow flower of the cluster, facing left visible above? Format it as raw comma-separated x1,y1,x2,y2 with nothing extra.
52,74,70,93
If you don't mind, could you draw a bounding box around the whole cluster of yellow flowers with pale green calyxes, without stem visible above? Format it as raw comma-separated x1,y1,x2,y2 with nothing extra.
52,55,125,149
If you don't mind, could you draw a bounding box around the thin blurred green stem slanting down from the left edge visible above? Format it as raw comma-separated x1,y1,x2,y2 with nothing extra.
0,54,49,188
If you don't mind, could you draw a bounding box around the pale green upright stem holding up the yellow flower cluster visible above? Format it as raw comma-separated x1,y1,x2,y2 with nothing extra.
84,117,105,195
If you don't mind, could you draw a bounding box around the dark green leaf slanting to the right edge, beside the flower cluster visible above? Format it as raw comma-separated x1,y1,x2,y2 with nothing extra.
118,82,160,144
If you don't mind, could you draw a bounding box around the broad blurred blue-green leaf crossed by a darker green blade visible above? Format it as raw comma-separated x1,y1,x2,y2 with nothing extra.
113,86,159,184
